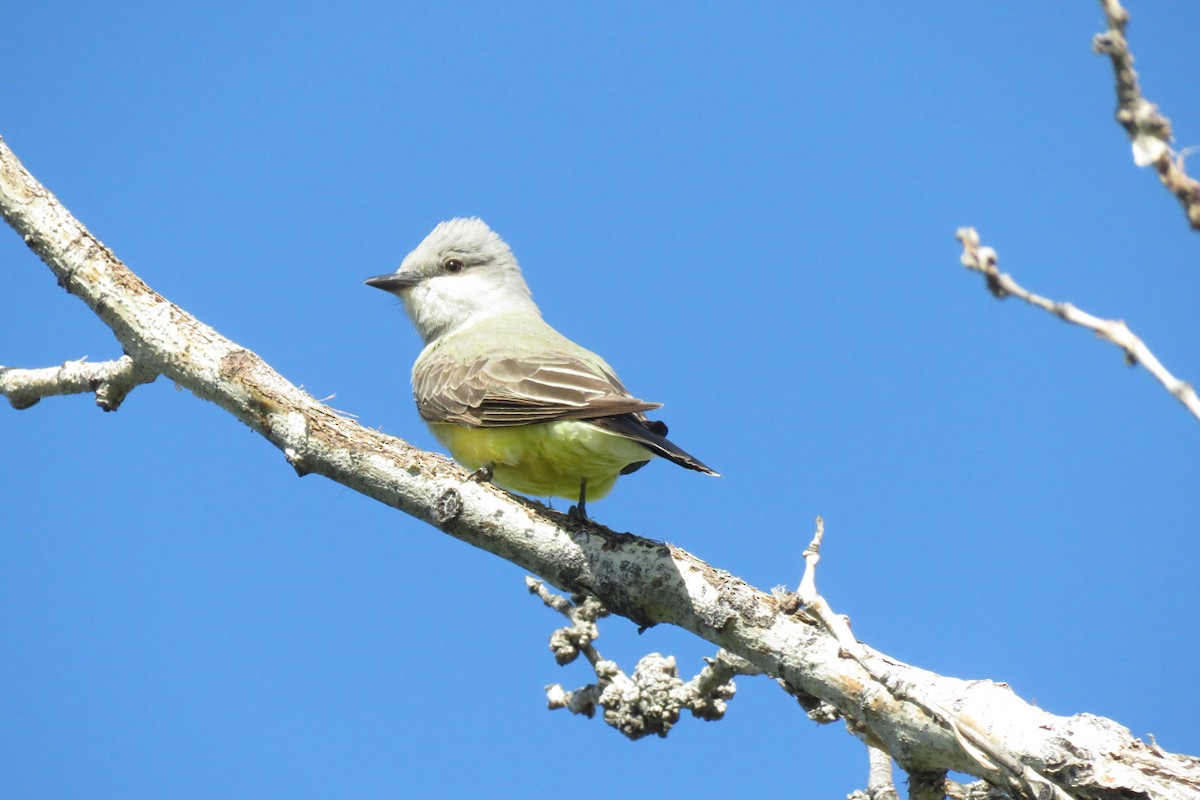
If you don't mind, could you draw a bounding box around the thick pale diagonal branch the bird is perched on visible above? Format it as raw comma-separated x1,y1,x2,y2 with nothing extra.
0,140,1200,799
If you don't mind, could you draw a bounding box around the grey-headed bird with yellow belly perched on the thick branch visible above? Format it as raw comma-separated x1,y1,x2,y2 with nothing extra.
366,217,716,518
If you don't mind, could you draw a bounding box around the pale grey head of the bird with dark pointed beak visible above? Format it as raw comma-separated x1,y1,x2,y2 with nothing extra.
366,217,538,342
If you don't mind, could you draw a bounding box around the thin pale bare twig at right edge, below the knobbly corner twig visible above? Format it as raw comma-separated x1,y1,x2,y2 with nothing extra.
956,228,1200,420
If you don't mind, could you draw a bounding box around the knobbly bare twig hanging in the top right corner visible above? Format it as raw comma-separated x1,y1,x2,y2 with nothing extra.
1092,0,1200,230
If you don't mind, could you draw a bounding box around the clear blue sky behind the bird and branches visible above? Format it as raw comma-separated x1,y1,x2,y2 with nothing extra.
0,0,1200,800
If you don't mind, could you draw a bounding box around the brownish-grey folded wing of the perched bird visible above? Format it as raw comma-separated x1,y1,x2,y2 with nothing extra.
413,326,661,428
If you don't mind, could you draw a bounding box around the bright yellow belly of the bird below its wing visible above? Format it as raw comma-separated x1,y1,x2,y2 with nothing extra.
430,420,654,500
